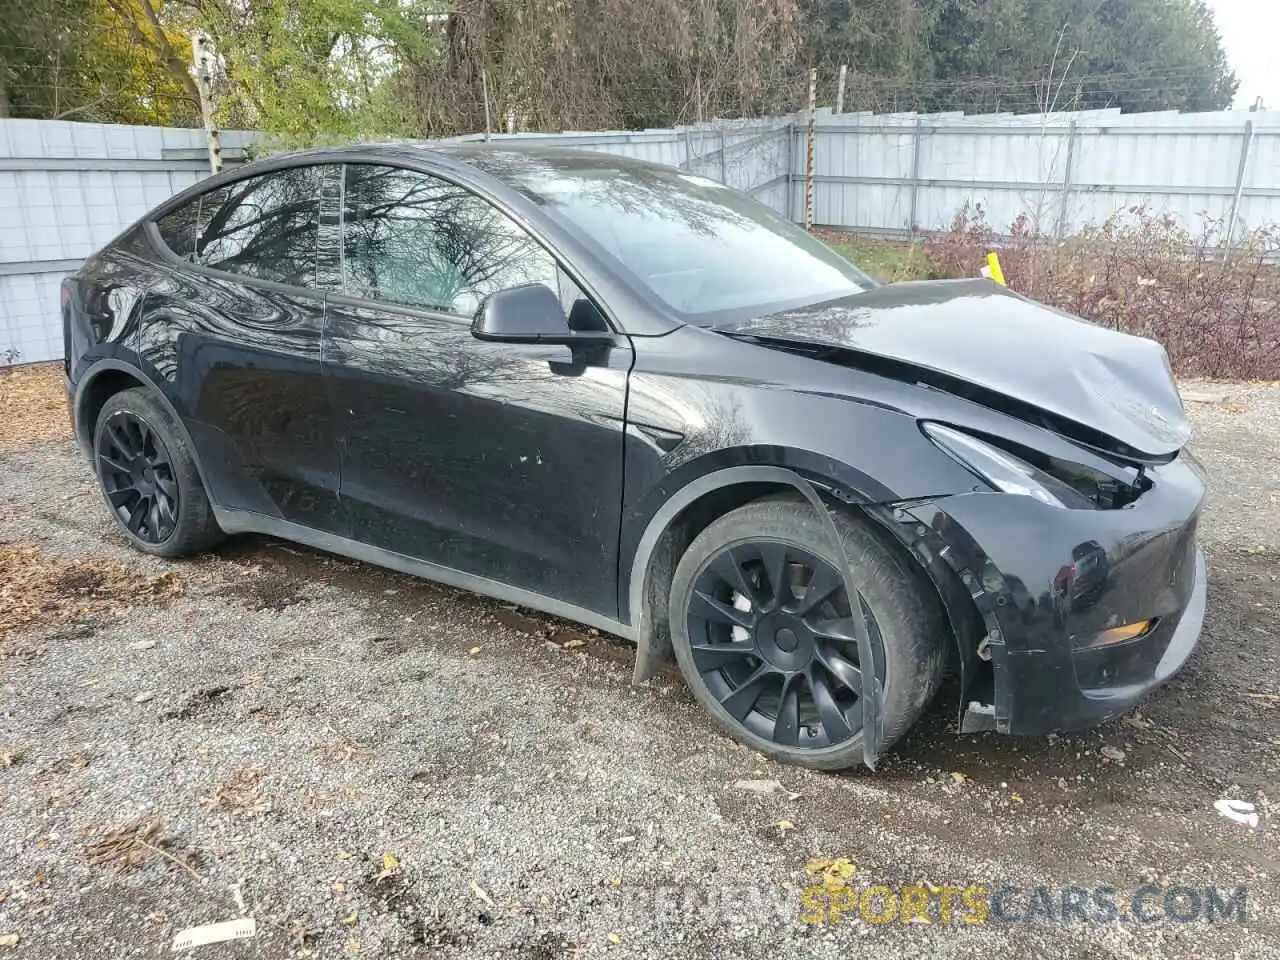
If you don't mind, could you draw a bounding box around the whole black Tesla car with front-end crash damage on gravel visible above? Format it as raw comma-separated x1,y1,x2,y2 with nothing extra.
61,143,1206,768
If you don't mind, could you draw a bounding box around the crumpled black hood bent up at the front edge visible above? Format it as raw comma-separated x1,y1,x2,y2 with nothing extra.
716,279,1192,457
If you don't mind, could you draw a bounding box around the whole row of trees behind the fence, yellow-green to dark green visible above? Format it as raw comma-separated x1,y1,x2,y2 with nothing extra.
0,0,1236,133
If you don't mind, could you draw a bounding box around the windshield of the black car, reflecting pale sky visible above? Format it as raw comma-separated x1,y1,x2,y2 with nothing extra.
481,155,873,323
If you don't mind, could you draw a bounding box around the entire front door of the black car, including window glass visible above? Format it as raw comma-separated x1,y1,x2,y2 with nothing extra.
325,164,631,617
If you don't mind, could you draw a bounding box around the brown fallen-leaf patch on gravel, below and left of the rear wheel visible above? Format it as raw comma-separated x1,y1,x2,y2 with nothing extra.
0,544,183,642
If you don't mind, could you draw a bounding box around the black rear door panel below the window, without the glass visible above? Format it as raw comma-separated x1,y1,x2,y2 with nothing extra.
138,259,339,532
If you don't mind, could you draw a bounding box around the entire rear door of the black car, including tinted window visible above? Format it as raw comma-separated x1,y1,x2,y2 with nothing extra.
140,165,343,532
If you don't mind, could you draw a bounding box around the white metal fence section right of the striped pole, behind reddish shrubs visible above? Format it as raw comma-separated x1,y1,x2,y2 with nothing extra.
792,110,1280,236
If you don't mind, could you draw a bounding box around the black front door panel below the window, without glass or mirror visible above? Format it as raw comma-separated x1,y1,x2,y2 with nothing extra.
325,296,632,617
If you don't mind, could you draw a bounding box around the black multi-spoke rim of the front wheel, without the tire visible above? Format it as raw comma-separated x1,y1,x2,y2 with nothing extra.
686,538,884,749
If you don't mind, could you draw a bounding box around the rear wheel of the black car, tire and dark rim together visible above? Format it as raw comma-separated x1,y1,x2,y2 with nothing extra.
93,388,224,557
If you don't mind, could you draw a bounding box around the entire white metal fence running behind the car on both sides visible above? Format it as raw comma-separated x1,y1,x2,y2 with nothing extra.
0,110,1280,362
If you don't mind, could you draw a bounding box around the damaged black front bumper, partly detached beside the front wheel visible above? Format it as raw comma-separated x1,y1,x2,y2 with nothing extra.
899,453,1207,733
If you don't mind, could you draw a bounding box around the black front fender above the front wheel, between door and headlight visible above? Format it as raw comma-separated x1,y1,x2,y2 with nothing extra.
620,326,982,618
